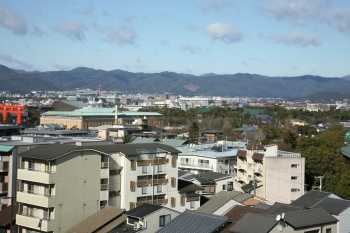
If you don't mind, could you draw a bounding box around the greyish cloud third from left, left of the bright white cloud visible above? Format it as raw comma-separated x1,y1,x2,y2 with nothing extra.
100,24,136,44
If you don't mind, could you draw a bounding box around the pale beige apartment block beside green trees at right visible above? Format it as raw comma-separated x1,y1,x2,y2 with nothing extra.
236,145,305,204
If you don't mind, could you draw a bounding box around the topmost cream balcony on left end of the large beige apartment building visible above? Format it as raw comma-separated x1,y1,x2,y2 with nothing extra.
17,169,56,184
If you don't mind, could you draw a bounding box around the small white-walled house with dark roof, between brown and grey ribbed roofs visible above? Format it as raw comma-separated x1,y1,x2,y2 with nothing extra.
108,204,180,233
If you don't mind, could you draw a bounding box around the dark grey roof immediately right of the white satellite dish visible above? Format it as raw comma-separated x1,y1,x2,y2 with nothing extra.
284,208,338,229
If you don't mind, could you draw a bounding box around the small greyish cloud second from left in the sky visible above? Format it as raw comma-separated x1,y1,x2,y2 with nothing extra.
53,21,86,41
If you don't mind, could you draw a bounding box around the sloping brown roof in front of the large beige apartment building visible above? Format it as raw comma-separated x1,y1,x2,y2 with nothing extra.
67,206,124,233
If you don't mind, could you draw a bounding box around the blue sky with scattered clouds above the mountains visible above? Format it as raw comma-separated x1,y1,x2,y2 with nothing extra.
0,0,350,77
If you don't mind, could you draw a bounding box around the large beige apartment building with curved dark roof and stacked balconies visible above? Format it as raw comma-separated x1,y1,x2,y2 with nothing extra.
16,143,179,232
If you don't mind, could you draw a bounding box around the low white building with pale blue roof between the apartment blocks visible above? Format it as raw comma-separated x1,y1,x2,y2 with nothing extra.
178,149,238,175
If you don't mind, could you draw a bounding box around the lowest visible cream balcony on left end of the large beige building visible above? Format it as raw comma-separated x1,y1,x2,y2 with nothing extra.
16,214,55,232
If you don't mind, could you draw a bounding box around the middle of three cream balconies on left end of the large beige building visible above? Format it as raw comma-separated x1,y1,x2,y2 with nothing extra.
17,192,56,208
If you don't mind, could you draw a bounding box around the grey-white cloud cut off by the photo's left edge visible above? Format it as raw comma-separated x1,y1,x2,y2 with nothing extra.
0,6,27,35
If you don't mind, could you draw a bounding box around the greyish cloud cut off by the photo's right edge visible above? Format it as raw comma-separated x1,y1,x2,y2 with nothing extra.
324,8,350,36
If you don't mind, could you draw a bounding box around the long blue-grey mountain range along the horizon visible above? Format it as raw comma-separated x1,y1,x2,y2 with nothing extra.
0,65,350,98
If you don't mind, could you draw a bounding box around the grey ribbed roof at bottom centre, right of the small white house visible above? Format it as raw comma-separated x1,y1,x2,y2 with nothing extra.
157,210,230,233
